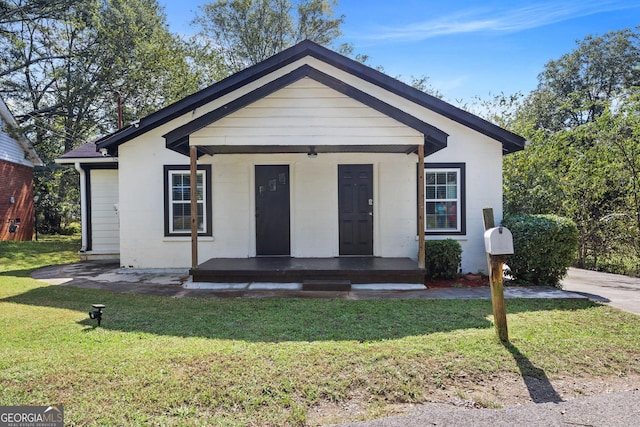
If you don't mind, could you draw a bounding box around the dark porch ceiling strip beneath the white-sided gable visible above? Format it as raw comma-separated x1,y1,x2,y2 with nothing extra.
197,145,418,156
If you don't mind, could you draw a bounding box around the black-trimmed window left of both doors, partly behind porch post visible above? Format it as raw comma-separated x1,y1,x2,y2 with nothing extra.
164,165,212,236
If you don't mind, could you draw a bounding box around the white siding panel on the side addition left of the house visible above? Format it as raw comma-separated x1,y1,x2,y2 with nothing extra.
91,169,120,253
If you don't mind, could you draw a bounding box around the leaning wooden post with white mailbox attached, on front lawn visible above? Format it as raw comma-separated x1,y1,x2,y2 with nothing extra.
482,208,513,341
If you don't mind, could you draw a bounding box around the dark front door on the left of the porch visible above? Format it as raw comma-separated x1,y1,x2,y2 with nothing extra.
256,165,291,256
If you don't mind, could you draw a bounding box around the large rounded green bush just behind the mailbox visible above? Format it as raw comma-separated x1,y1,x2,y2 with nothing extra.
502,215,578,287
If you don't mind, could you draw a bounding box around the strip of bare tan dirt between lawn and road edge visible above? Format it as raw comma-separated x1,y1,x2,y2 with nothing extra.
307,372,640,425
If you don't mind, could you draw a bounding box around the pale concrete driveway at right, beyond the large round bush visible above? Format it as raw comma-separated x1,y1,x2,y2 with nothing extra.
562,268,640,314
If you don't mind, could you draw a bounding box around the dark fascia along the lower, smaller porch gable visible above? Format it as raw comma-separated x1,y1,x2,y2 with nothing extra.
164,65,449,155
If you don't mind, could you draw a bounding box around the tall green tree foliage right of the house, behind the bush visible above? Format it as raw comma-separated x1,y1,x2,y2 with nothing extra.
504,29,640,272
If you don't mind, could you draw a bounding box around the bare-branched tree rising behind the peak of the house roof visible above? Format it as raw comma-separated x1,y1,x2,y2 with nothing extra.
194,0,348,74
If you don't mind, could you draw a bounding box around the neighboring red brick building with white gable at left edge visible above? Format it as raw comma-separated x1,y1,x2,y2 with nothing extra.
0,98,42,244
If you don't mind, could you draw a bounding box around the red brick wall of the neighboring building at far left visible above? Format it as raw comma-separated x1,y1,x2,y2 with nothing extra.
0,160,34,240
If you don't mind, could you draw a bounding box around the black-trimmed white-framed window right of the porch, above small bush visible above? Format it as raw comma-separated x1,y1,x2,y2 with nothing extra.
424,163,466,234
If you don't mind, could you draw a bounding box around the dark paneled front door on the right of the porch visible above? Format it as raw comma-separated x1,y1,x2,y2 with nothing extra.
338,165,373,255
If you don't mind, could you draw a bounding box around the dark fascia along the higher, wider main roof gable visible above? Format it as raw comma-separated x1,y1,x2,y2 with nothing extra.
96,40,525,154
